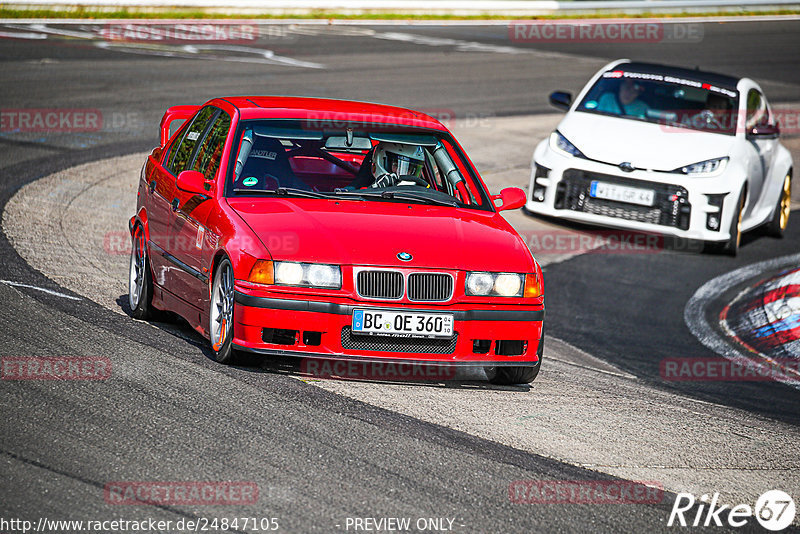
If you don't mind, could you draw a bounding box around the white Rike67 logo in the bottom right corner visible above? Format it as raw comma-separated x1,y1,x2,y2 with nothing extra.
667,490,796,532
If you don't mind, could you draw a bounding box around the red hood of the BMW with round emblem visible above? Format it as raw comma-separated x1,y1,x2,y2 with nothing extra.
228,198,533,272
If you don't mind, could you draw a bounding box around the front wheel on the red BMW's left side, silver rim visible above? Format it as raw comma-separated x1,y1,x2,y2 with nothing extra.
208,258,237,364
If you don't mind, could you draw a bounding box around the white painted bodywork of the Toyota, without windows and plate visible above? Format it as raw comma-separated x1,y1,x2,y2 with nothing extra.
526,60,792,242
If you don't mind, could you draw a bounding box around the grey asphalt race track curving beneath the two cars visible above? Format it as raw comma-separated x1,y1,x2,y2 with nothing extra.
0,20,800,532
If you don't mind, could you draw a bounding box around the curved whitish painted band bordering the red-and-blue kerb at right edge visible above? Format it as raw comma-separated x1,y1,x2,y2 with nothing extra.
683,253,800,389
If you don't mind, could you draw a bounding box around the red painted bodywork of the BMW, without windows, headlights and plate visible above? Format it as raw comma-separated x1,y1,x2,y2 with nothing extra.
130,97,544,365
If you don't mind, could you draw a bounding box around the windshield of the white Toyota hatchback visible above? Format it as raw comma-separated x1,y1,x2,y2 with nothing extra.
577,70,739,135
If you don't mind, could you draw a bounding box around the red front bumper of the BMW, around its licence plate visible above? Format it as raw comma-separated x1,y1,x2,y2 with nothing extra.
233,288,544,366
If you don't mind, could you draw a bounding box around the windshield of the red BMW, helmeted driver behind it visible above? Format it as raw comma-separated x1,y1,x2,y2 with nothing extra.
226,119,492,210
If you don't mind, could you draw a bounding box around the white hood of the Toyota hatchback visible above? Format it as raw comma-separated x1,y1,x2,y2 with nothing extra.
558,111,735,171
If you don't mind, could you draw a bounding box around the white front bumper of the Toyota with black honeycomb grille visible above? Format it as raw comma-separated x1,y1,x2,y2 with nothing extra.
525,146,744,242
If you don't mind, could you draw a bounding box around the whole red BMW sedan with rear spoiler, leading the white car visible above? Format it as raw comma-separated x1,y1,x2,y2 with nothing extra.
129,97,544,384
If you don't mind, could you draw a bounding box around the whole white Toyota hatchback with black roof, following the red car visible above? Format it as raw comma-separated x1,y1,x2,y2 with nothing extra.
526,60,792,254
